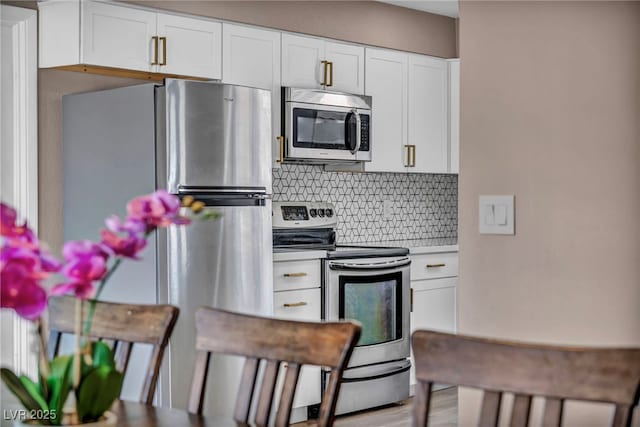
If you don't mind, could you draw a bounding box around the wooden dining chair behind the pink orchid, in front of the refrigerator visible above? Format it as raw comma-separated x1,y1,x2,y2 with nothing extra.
48,297,180,405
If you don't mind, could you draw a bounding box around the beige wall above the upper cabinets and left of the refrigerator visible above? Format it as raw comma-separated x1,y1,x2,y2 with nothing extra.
33,1,456,250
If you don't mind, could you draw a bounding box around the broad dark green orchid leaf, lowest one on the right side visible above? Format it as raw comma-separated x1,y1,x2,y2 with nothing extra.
76,366,124,422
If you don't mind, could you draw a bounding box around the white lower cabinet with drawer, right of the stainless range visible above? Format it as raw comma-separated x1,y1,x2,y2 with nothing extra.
409,252,458,390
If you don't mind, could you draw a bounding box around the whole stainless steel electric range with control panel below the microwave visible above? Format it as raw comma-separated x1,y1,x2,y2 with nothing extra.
273,202,411,414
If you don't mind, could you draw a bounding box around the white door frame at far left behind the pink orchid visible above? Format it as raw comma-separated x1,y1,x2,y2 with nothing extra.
0,5,38,377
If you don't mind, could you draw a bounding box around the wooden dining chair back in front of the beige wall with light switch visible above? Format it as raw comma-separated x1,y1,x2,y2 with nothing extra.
412,331,640,427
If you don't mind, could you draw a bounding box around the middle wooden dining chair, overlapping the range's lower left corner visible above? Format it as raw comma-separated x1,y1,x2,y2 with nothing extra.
189,308,361,427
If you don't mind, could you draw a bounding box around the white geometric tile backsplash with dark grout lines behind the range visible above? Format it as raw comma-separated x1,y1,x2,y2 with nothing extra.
273,164,458,243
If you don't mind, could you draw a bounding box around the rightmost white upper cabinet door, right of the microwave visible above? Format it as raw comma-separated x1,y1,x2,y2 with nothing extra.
408,55,449,173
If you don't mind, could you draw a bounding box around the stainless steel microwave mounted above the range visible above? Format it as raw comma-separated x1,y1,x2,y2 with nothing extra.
280,87,371,163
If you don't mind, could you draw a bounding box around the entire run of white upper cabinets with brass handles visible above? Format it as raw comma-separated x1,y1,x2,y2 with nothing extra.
38,0,460,173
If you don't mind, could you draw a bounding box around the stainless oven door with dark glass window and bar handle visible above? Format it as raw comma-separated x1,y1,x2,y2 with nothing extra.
324,257,411,367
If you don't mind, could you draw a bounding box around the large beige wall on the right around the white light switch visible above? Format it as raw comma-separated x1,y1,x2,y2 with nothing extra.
458,1,640,426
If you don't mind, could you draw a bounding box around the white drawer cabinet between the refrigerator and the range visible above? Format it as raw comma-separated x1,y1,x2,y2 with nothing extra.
273,259,322,422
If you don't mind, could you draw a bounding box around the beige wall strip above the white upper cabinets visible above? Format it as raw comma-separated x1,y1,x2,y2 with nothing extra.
126,0,457,58
